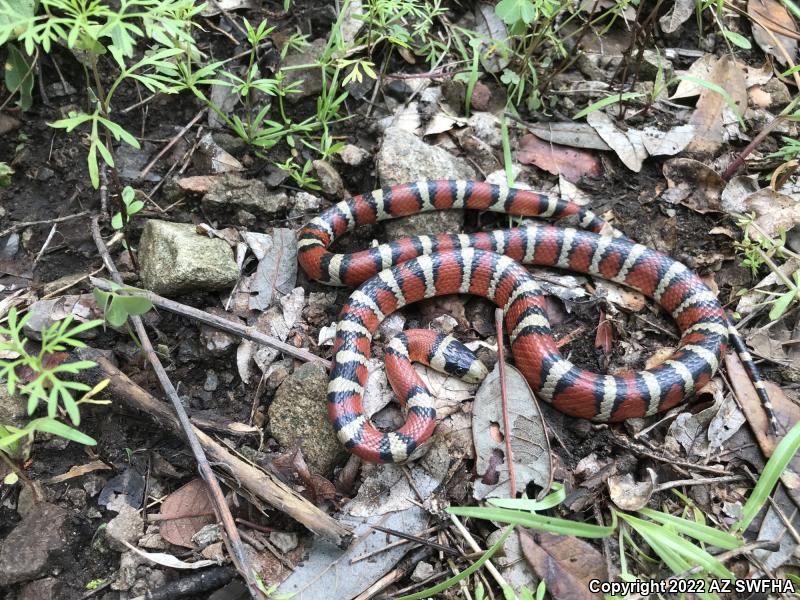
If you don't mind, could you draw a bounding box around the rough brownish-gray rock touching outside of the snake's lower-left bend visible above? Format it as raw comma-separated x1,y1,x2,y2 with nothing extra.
268,362,347,475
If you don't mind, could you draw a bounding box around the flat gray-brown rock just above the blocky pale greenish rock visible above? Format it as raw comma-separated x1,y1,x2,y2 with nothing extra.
202,175,289,219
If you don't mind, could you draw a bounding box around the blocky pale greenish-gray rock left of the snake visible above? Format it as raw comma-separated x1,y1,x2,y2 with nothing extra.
139,219,239,296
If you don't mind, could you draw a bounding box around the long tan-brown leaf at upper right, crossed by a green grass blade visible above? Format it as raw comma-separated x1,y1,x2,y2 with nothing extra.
687,55,747,154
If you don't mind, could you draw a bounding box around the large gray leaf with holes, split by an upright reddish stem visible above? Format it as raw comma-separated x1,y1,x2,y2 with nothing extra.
472,365,550,500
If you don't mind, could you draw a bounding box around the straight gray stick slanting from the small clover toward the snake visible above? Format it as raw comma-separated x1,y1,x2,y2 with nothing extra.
84,277,331,371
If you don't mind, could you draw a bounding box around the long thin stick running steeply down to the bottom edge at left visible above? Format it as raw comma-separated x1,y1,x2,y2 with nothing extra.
92,217,261,598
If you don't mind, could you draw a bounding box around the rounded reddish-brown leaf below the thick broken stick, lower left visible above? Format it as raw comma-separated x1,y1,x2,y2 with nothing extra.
159,479,216,548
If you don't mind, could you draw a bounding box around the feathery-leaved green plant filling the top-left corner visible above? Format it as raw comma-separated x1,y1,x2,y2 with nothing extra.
0,0,204,188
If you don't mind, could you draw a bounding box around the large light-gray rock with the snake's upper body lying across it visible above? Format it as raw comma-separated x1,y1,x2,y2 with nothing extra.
377,127,475,238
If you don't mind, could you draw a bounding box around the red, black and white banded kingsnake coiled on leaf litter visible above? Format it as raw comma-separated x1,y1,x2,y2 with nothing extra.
298,180,775,462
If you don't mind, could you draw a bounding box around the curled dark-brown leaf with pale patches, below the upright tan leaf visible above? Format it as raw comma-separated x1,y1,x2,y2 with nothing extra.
661,158,725,213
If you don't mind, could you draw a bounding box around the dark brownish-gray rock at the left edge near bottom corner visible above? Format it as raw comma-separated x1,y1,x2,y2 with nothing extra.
0,503,71,587
